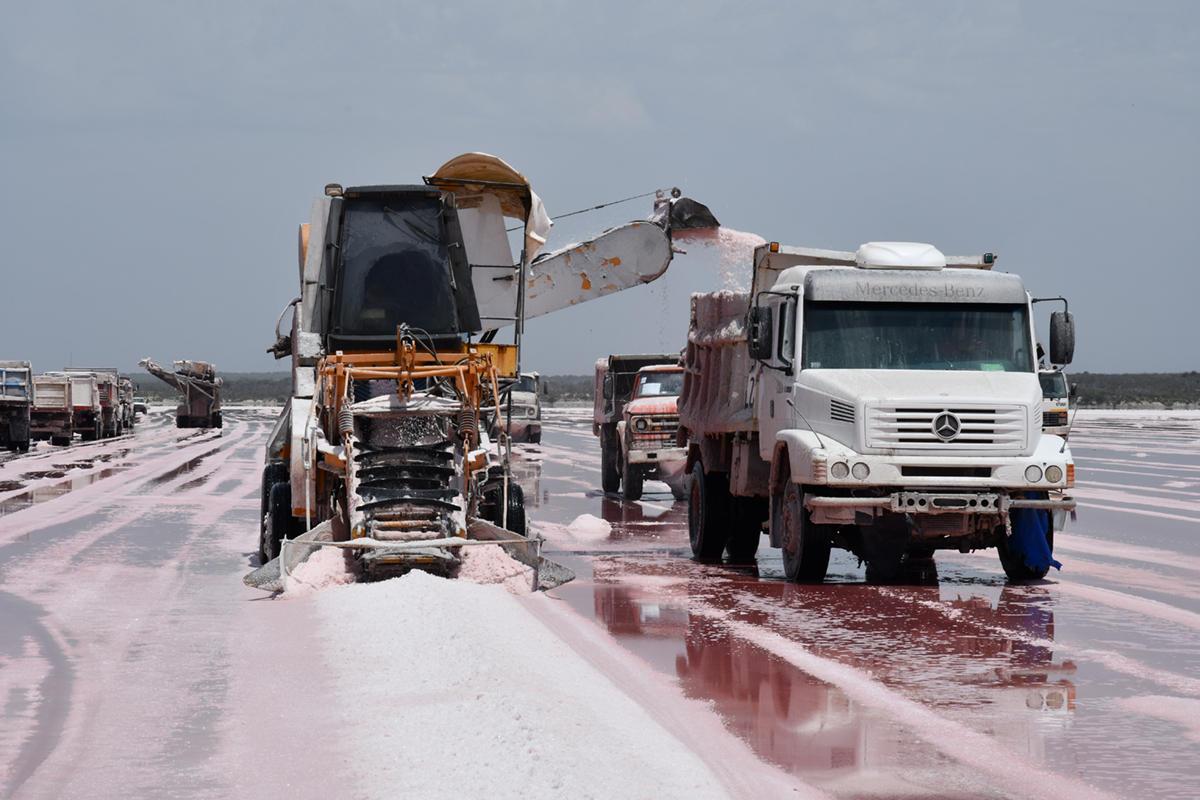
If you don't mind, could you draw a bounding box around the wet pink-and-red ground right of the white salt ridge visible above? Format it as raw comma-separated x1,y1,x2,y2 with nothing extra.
524,413,1200,798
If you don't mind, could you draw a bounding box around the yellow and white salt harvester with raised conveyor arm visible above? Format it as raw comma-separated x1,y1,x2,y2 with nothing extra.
246,154,710,590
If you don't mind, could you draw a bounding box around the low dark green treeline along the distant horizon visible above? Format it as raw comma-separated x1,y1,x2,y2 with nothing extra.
133,372,1200,408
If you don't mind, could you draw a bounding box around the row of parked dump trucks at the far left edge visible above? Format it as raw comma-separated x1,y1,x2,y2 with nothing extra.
0,361,145,452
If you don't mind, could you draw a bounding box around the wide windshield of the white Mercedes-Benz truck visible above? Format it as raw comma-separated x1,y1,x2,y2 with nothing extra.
800,301,1033,372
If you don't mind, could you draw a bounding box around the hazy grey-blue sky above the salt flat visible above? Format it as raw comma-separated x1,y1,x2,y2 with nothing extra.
0,1,1200,373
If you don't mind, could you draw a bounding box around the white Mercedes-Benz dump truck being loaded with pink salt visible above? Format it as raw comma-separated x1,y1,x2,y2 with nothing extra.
679,242,1075,582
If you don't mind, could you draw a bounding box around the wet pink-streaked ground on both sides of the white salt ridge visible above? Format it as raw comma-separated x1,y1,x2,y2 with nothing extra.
0,409,1200,798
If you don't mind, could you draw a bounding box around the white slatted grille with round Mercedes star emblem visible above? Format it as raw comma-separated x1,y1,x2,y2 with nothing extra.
866,405,1027,450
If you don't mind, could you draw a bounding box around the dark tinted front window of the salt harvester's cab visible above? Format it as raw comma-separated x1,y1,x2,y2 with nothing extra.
334,197,457,336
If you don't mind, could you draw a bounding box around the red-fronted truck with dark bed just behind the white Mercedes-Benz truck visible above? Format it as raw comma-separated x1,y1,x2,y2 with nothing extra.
592,354,686,500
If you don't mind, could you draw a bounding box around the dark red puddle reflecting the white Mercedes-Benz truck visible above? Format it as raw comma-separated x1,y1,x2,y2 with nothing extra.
580,557,1075,782
